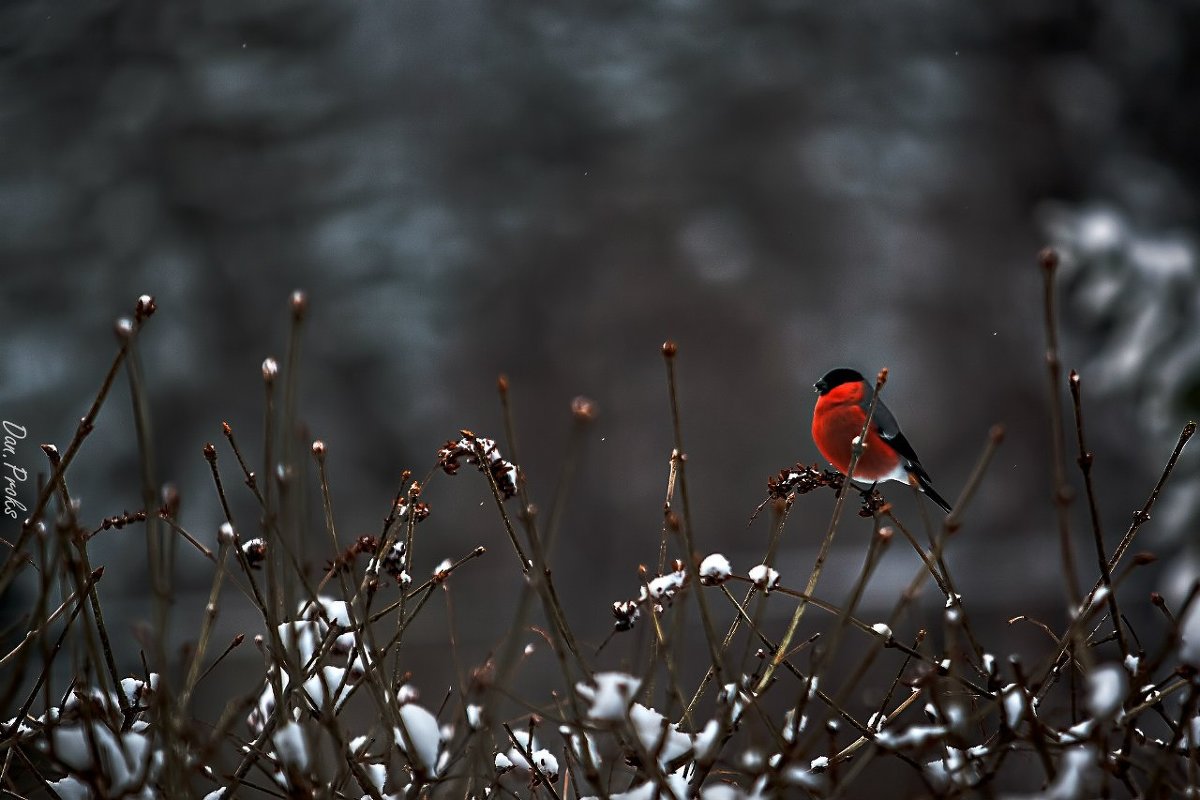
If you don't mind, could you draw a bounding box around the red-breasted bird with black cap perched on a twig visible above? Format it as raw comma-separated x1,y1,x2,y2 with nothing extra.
812,367,950,513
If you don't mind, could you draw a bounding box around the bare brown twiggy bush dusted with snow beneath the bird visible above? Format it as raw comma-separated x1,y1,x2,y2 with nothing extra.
0,283,1200,800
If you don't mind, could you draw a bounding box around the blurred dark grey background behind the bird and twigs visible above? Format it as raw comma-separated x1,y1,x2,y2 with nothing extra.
0,0,1200,796
